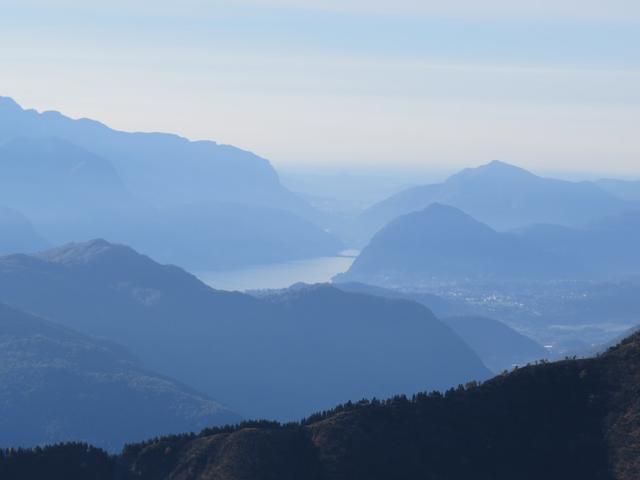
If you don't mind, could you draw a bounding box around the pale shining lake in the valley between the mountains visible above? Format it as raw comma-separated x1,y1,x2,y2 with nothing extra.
195,251,358,291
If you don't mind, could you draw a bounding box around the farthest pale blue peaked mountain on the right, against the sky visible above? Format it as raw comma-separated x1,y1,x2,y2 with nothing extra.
358,161,632,241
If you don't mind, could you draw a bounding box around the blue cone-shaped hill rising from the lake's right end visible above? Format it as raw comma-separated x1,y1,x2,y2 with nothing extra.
336,204,580,285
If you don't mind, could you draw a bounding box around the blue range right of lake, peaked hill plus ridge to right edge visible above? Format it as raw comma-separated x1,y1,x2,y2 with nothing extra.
337,204,640,286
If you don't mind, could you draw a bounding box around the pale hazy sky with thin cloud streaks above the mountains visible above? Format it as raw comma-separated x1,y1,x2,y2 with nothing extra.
0,0,640,176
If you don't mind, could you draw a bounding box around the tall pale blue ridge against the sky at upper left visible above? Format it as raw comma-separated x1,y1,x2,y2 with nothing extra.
0,97,309,213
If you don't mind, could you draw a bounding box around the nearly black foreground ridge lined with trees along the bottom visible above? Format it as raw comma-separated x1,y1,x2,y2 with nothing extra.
5,334,640,480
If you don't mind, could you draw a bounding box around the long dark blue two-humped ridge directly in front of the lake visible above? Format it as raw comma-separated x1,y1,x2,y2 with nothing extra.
0,240,490,420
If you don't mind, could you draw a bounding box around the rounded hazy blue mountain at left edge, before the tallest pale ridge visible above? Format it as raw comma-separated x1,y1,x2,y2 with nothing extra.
0,139,148,243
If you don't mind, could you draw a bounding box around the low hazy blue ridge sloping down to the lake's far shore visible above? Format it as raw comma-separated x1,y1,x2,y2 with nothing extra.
155,203,344,271
